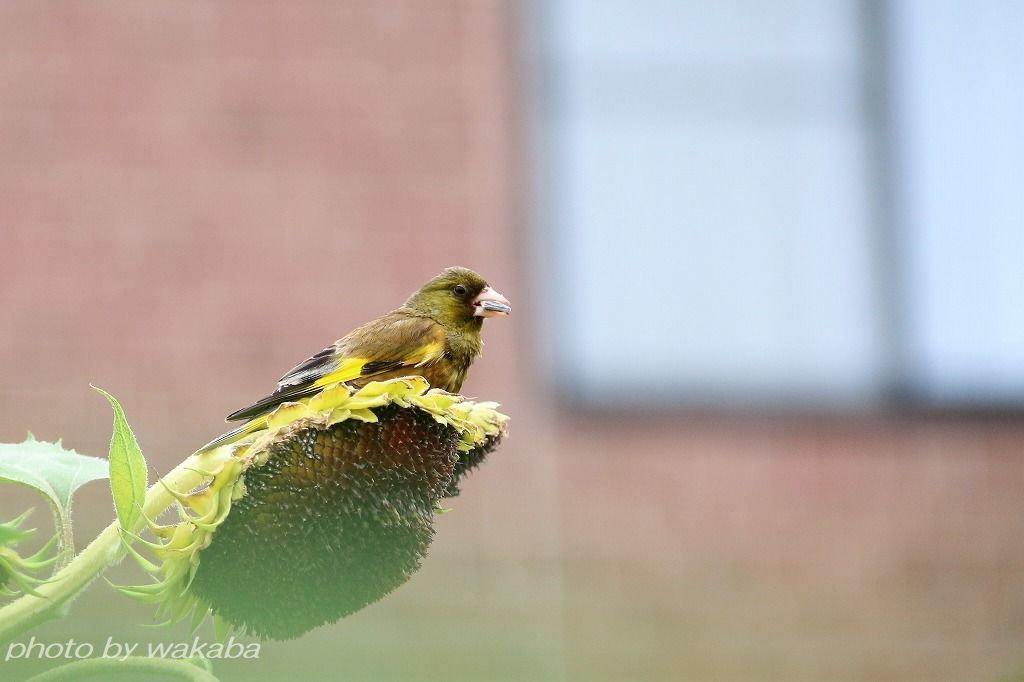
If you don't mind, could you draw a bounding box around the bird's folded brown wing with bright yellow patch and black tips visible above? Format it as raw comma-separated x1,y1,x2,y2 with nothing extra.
227,312,444,422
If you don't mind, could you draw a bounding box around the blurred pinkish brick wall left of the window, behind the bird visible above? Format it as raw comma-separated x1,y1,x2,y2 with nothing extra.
0,0,561,679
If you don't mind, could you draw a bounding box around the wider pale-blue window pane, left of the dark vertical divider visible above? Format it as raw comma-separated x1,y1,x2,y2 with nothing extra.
542,0,883,404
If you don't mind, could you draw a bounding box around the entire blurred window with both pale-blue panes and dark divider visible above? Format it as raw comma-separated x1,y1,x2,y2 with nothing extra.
530,0,1024,407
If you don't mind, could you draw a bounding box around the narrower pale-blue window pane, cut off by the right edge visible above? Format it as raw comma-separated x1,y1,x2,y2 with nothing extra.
890,0,1024,402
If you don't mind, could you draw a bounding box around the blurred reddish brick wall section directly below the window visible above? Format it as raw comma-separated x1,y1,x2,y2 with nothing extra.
558,415,1024,682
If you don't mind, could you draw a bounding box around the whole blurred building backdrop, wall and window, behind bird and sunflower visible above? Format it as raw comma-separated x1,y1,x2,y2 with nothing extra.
0,0,1024,682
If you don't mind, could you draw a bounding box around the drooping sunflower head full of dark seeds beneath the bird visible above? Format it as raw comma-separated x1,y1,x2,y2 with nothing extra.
120,377,508,638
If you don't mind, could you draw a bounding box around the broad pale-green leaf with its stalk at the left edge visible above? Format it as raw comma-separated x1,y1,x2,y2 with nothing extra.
0,433,106,565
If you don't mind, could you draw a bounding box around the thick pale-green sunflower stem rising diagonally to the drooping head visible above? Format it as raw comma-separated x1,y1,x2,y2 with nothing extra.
0,455,208,643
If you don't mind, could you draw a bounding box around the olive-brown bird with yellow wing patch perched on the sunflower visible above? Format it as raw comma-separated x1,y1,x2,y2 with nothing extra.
199,267,512,453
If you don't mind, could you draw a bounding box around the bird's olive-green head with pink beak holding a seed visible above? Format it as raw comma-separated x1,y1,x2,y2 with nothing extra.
406,267,512,328
